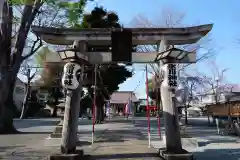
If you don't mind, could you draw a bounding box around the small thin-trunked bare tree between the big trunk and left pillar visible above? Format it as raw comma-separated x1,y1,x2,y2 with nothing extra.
20,59,37,119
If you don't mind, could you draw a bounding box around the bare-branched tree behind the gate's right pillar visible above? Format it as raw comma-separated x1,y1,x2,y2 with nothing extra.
132,8,216,112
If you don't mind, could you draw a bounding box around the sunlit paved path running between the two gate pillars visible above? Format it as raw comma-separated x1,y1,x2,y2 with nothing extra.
87,120,160,160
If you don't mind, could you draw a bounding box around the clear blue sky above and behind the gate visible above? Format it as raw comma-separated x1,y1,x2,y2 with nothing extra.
86,0,240,97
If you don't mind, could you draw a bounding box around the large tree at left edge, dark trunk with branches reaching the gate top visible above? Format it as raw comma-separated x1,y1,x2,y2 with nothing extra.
0,0,87,133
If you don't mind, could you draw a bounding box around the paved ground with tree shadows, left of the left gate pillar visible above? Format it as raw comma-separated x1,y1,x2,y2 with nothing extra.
0,119,59,160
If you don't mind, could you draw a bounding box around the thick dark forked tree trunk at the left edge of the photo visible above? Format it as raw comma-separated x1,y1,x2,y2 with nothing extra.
0,3,42,134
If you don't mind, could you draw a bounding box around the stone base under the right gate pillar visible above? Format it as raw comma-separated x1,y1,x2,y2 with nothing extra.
159,148,195,160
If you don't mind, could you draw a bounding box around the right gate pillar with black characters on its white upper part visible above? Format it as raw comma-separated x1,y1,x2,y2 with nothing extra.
159,40,182,153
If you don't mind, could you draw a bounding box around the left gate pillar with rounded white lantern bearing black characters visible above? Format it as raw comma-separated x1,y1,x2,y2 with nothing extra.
61,62,83,154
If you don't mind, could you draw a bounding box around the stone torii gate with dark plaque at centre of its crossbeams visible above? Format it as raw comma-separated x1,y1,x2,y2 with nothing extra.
32,24,213,158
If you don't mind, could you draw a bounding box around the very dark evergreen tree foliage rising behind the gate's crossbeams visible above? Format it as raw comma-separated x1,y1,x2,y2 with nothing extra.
80,7,132,94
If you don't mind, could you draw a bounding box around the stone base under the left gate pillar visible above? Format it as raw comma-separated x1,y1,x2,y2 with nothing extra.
48,150,86,160
